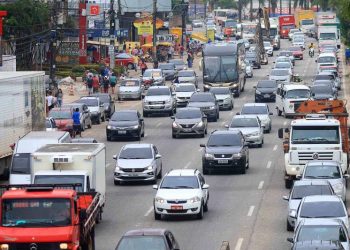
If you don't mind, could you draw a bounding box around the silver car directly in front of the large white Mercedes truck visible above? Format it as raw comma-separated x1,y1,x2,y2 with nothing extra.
297,161,349,201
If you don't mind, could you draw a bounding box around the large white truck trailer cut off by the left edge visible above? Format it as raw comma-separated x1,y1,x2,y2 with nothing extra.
0,71,46,178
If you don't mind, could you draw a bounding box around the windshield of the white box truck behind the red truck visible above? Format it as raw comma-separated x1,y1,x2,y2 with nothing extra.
34,174,84,192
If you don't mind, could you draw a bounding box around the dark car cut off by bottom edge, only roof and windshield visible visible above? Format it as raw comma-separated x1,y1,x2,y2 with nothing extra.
115,228,180,250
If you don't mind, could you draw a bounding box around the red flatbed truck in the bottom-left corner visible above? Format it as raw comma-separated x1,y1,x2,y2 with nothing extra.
0,185,99,250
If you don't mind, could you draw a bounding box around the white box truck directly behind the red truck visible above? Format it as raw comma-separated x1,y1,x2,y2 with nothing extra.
31,143,106,219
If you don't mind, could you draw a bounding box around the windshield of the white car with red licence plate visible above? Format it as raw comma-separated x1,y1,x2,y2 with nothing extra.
160,176,199,189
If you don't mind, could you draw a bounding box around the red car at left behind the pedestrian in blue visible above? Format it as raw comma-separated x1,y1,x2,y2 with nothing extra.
49,108,73,133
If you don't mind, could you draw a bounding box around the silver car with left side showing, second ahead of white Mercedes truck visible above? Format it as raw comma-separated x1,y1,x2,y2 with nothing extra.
283,180,334,231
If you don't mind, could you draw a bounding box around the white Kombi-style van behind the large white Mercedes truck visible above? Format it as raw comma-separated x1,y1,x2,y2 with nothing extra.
276,83,310,117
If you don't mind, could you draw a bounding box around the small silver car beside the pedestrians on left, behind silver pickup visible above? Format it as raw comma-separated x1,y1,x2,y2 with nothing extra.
118,78,145,100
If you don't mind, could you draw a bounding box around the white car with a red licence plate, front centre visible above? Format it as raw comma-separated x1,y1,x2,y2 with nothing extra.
153,169,209,220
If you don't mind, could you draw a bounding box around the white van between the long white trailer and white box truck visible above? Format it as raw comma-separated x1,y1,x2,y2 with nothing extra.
9,131,72,185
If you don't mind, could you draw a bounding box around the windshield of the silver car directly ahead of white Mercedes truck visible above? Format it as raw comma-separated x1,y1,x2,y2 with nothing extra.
304,164,341,179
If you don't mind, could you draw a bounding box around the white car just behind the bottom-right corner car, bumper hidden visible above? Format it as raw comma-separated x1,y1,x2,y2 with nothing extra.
295,195,349,229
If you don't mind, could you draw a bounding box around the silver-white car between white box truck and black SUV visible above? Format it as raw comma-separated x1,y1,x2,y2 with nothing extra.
113,143,163,185
